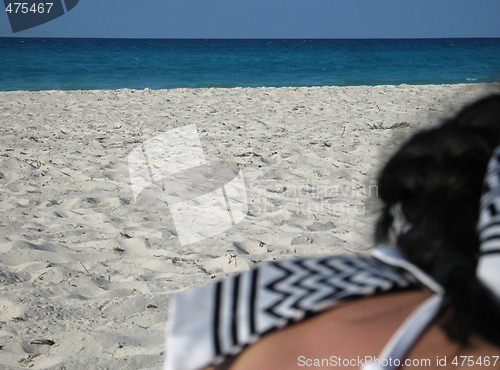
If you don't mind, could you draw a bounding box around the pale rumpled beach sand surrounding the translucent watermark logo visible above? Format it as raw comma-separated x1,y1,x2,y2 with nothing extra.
0,84,500,369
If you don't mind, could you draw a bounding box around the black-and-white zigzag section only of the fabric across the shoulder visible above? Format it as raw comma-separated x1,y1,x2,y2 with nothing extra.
264,256,414,321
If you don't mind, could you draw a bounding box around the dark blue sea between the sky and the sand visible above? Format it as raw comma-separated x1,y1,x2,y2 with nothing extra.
0,38,500,91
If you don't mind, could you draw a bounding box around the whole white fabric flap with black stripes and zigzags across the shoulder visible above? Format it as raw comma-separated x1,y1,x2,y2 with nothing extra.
166,251,418,370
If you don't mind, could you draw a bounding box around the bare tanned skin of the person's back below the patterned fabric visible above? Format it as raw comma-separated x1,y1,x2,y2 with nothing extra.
206,290,500,370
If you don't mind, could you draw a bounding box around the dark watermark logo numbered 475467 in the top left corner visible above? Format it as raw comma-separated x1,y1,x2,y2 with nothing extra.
4,0,79,33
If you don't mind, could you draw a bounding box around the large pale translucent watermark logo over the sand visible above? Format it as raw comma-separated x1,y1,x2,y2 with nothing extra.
128,124,248,245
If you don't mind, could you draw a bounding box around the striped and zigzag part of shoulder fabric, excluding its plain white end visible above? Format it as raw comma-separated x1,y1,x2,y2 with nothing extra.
212,256,417,358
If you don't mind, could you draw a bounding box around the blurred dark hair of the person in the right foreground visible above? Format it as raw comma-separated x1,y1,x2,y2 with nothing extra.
376,95,500,345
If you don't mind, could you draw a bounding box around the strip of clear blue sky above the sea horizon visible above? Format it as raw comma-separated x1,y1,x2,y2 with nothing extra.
0,0,500,38
